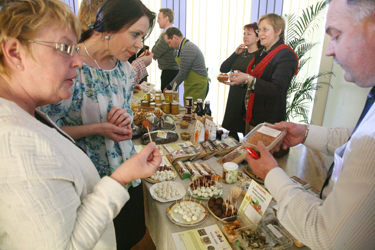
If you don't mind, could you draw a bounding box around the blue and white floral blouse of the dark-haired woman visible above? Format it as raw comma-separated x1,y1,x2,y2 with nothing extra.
40,61,141,187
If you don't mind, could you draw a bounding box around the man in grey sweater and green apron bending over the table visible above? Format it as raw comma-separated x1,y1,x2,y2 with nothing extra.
164,27,208,103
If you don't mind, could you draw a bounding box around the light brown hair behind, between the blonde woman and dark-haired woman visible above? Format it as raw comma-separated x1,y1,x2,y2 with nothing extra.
78,0,107,33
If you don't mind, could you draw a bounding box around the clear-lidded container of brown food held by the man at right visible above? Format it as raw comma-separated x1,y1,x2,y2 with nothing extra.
242,122,286,154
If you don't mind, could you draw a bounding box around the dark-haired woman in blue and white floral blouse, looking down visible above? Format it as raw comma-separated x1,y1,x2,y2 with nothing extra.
41,0,156,249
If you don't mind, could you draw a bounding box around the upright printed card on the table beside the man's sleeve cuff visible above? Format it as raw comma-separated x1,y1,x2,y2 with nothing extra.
239,180,272,224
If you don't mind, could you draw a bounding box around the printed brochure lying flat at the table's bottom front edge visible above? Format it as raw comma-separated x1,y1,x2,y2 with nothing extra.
172,224,232,250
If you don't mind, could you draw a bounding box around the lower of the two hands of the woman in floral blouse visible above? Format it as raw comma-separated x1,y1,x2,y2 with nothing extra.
98,122,133,142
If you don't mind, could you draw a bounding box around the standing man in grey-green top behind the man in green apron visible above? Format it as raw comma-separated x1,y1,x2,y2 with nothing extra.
151,8,179,90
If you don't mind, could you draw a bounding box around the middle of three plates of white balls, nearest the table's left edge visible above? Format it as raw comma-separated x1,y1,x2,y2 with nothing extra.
150,181,186,202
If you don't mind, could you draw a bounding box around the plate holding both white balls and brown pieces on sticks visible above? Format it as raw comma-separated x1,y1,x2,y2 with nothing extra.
188,177,223,200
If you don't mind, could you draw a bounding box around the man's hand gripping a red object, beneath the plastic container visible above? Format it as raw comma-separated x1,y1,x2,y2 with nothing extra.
246,141,279,180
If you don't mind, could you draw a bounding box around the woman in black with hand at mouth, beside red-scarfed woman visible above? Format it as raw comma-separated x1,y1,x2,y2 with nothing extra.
220,23,260,140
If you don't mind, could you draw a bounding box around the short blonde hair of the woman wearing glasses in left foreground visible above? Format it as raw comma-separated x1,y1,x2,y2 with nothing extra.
0,0,81,74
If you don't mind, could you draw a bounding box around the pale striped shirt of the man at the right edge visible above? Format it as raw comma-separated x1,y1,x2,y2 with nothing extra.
265,105,375,249
